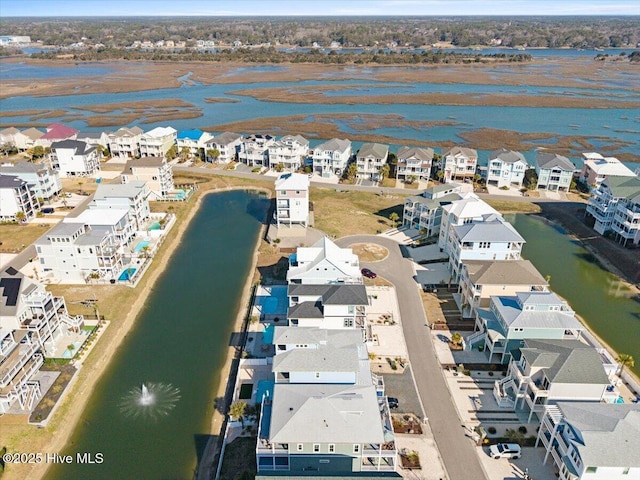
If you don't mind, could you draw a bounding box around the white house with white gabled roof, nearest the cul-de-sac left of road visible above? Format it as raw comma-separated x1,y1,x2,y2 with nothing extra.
287,237,362,285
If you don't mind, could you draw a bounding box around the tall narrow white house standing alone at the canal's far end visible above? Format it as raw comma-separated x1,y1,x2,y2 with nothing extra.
276,173,309,228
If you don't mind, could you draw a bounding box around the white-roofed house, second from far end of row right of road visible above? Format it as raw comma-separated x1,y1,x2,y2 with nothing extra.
438,193,502,254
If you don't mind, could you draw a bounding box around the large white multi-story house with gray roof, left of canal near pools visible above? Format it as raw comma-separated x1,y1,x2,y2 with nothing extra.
34,222,123,283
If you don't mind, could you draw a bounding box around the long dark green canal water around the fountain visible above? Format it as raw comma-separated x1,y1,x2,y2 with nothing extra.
48,191,268,479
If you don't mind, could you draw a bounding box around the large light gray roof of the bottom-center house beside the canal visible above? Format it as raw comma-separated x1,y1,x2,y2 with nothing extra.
269,383,384,444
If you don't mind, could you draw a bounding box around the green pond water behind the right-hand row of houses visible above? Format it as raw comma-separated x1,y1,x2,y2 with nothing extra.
507,215,640,374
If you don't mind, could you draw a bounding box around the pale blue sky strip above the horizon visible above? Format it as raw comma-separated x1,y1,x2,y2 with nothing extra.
0,0,640,18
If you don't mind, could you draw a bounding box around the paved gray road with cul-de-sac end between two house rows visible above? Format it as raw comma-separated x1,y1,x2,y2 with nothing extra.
336,235,487,480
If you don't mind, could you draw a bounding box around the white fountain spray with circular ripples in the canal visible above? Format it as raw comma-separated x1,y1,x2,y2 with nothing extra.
120,382,180,420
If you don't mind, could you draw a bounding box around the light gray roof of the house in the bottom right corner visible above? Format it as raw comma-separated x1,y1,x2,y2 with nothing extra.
558,402,640,468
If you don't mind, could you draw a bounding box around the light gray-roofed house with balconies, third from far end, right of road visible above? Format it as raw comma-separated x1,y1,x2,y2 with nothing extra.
449,218,525,282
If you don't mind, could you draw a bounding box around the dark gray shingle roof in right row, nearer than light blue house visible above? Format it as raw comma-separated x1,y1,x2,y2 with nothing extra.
520,340,610,386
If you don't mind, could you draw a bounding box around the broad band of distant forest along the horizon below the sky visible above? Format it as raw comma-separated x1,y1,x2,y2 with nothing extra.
0,17,640,48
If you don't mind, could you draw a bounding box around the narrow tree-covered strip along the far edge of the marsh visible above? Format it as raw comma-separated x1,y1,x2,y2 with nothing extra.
31,47,531,65
